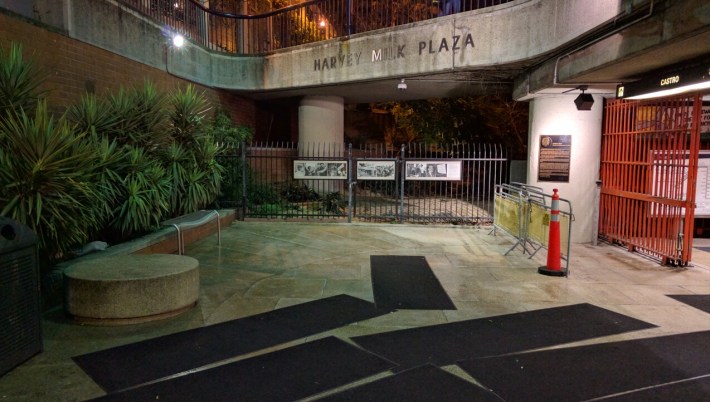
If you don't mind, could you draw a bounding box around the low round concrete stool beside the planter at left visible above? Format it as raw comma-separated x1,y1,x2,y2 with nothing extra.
64,254,200,325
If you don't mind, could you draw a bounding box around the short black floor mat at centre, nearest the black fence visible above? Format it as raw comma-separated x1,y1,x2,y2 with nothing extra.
370,255,456,310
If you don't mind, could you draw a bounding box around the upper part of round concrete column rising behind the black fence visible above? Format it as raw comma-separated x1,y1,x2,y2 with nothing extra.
298,96,345,144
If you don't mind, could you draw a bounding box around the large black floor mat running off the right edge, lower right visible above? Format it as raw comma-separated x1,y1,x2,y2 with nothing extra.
457,331,710,401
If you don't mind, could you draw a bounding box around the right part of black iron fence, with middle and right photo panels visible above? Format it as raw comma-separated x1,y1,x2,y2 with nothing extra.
351,144,508,224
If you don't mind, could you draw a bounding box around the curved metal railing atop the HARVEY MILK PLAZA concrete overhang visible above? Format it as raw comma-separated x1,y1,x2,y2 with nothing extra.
119,0,513,54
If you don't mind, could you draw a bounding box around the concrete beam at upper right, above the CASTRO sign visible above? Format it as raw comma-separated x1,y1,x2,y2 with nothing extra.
513,0,710,100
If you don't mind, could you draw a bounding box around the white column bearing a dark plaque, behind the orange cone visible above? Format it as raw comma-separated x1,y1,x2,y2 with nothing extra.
527,93,603,243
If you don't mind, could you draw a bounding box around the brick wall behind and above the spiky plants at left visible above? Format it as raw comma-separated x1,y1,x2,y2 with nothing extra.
0,10,256,127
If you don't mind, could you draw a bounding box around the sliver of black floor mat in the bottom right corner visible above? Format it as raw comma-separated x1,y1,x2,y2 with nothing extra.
604,377,710,402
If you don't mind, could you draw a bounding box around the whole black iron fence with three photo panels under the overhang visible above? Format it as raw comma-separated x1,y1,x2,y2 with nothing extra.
218,143,509,225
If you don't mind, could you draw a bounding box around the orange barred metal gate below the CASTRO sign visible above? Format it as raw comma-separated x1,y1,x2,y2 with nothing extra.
599,95,702,265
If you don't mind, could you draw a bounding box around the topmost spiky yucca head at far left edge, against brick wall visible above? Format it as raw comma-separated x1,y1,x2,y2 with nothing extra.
0,42,44,118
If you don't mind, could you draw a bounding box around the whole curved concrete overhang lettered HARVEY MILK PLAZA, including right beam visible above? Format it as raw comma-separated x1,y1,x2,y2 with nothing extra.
30,0,710,103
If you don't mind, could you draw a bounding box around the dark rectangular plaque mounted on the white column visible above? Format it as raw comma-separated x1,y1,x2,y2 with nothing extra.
537,135,572,183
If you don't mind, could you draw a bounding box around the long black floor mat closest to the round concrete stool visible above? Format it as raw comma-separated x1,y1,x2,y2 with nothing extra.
74,295,387,391
